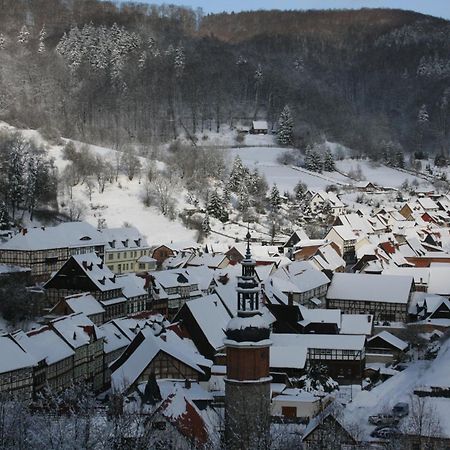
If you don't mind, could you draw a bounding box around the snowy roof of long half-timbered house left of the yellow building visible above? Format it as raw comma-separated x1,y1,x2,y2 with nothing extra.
0,222,105,250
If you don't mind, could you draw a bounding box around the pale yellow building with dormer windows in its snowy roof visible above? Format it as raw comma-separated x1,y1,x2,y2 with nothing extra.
102,227,156,274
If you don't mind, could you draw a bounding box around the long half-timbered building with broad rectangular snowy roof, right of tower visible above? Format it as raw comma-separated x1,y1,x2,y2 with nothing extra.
327,273,414,322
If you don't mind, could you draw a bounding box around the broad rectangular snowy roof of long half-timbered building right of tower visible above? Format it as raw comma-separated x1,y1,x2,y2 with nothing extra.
327,273,413,304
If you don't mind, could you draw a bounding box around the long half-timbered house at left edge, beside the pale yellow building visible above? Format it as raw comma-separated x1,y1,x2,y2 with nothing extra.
0,222,105,281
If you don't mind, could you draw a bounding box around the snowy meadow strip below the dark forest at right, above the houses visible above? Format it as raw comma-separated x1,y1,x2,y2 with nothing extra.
336,159,430,188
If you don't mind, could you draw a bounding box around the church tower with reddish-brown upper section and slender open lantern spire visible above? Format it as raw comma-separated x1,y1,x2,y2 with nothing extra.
224,232,271,450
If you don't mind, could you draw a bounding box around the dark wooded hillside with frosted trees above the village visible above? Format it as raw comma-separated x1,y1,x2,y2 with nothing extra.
0,0,450,157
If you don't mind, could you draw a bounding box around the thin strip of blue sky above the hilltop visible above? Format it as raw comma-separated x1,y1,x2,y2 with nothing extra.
141,0,450,19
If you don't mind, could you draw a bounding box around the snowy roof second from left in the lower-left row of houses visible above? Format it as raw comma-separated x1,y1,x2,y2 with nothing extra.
14,326,75,365
